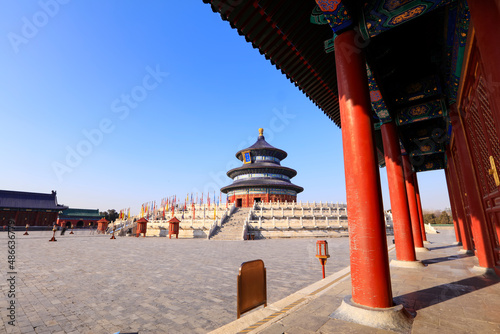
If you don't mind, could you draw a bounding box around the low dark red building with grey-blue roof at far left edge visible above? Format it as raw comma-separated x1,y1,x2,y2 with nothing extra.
0,190,68,226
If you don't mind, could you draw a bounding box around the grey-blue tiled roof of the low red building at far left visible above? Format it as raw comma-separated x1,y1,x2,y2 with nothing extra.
0,190,68,210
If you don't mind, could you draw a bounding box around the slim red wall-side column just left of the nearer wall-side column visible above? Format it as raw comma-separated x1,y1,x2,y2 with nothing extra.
446,150,474,252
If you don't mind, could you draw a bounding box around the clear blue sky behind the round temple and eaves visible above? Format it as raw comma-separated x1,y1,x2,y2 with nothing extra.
0,0,449,213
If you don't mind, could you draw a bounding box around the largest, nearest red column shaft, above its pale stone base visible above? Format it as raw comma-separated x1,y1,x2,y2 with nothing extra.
335,30,393,308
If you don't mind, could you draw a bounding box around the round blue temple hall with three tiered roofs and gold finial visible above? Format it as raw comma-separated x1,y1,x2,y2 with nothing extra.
221,128,304,207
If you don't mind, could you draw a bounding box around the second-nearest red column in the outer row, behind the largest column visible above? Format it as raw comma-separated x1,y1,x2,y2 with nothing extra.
380,122,417,261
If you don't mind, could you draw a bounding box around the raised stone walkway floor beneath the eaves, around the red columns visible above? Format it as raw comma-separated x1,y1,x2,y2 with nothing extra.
254,229,500,334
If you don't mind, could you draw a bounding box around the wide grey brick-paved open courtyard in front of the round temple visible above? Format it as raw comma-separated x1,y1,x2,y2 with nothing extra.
0,231,392,334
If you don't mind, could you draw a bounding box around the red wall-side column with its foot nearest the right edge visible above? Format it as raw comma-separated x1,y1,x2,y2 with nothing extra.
450,110,495,268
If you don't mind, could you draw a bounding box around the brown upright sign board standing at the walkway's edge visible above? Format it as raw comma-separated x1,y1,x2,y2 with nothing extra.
237,260,267,319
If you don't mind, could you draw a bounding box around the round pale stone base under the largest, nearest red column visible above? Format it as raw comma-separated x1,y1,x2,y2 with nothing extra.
330,296,413,333
